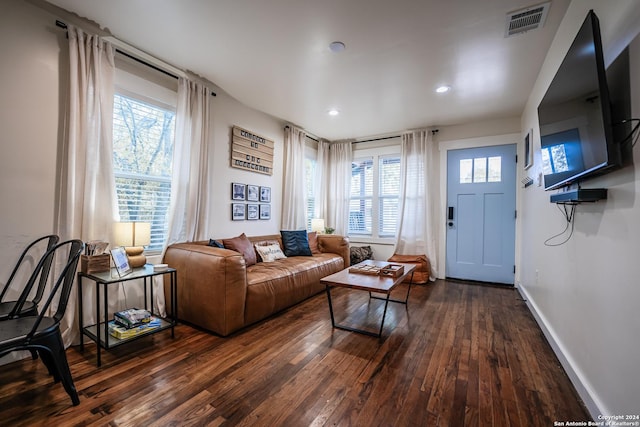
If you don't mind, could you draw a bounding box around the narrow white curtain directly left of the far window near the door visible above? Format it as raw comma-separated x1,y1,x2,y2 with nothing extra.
325,141,353,236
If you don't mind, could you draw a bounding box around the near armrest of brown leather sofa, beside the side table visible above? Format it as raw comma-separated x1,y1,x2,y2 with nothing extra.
164,242,247,336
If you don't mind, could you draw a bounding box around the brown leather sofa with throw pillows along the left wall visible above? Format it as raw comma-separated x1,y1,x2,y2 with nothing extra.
164,235,349,336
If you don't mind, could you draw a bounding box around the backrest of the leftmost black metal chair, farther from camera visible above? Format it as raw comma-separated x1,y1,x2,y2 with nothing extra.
0,234,60,305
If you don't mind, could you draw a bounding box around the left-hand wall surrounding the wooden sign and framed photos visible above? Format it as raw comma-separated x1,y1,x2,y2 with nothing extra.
0,0,284,282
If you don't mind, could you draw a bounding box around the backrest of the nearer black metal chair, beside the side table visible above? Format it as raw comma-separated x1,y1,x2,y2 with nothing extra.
27,239,84,336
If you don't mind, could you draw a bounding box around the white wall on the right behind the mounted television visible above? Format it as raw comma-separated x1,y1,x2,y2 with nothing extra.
517,0,640,419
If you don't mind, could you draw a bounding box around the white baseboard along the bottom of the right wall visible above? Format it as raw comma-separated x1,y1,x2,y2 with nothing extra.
516,284,608,420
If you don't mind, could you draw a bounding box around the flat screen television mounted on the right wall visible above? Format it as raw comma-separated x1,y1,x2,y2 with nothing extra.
538,11,621,190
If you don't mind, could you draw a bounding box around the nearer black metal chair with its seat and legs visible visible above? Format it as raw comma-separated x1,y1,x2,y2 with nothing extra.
0,240,84,406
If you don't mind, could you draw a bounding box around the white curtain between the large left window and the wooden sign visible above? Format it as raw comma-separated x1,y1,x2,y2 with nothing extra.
167,77,210,246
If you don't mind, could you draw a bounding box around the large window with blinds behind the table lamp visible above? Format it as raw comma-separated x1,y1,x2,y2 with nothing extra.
113,93,175,251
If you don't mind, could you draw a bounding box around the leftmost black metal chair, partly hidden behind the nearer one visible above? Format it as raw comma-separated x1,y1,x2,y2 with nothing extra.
0,235,59,321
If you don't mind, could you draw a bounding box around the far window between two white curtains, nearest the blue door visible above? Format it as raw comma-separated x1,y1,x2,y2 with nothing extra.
349,155,400,238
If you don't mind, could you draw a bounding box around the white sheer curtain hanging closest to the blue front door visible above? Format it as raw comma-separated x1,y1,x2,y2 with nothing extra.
395,130,440,280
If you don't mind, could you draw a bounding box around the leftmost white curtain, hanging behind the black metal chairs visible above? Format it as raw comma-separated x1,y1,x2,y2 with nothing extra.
56,25,118,346
